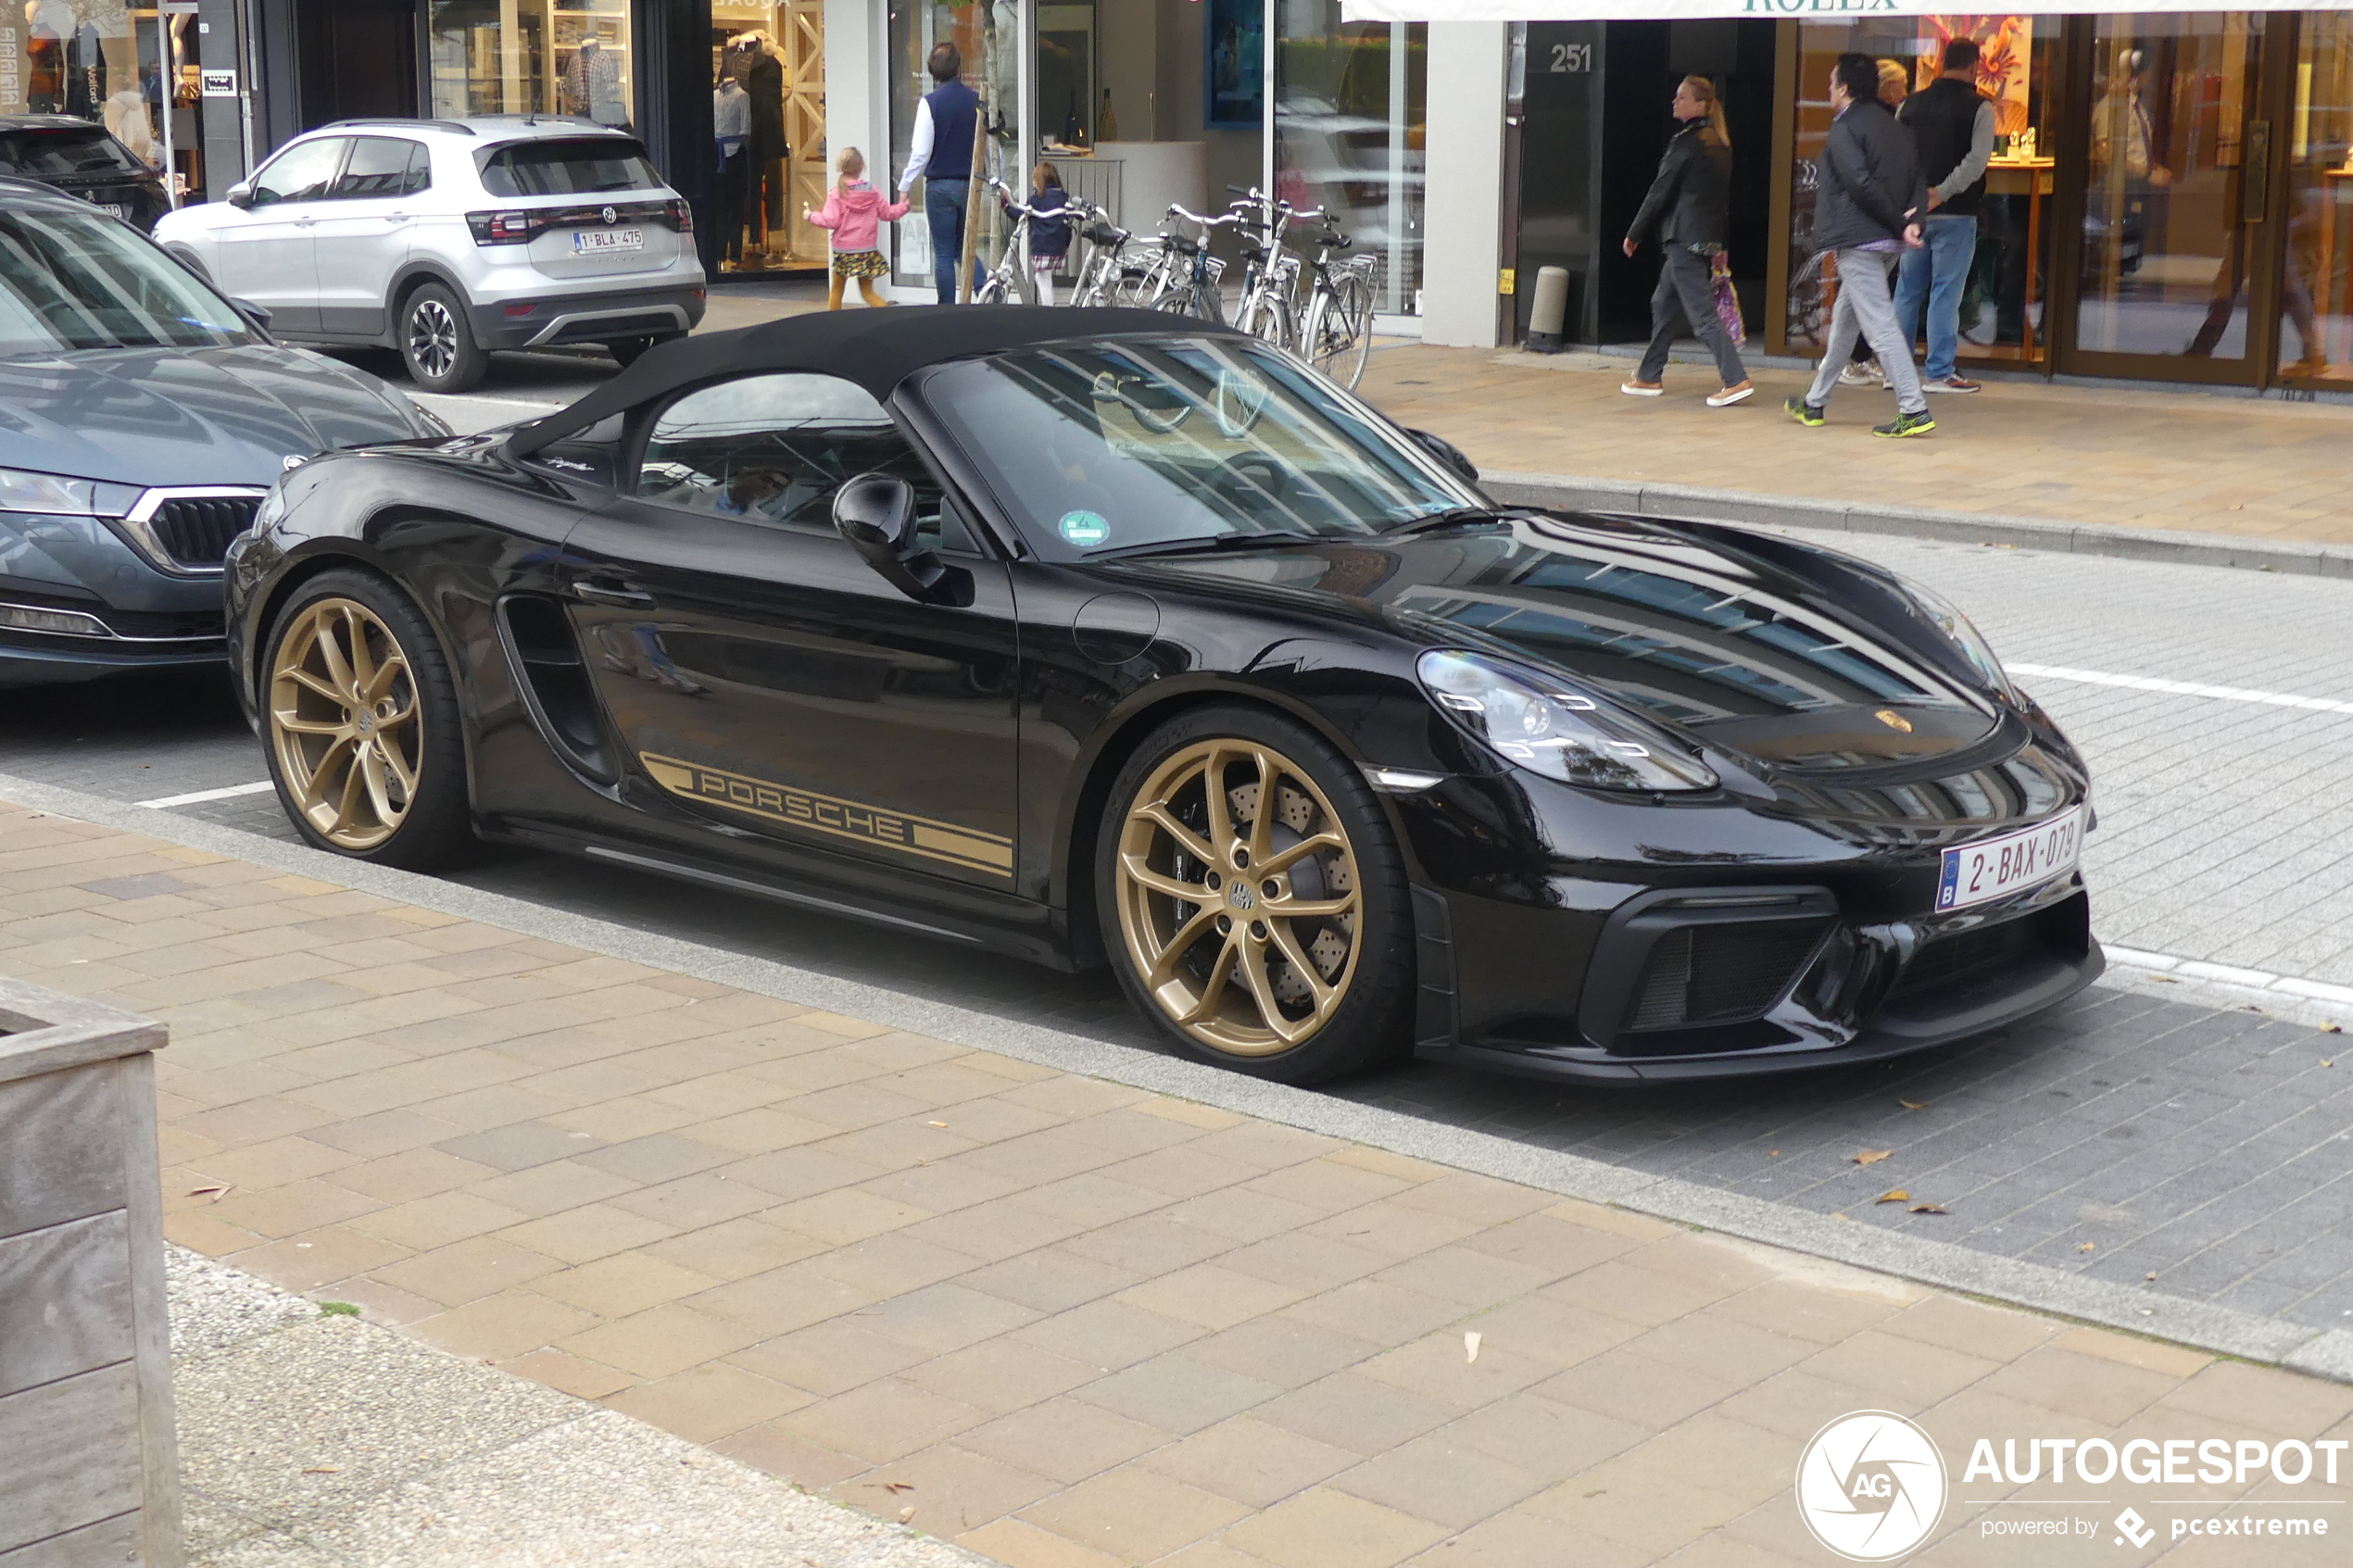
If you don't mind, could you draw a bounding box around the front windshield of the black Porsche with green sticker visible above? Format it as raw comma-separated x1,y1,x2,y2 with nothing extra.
923,336,1482,559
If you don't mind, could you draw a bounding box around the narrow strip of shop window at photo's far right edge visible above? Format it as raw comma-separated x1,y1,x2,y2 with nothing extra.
2280,12,2353,383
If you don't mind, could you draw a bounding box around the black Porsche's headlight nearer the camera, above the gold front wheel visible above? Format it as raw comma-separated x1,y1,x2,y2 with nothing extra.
1415,649,1716,790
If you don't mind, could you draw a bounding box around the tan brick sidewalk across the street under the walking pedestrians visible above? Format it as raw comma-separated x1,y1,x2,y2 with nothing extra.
1363,344,2353,543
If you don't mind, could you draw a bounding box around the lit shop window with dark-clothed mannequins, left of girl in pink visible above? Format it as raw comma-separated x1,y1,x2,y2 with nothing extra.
711,0,828,272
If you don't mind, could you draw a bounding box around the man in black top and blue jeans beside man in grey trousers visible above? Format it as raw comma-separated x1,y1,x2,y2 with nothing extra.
1896,38,1993,393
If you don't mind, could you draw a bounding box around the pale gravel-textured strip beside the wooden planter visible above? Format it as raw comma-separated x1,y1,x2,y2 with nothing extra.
167,1246,986,1568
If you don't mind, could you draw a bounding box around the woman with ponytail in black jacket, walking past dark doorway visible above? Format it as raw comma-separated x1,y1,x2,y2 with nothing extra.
1619,75,1755,409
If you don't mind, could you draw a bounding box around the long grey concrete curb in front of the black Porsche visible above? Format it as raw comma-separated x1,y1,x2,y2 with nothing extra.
0,773,2353,1382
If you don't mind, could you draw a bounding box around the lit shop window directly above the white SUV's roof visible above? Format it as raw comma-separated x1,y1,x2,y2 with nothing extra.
426,0,635,127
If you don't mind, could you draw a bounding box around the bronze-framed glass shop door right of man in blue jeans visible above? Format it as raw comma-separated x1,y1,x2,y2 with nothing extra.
2064,12,2268,383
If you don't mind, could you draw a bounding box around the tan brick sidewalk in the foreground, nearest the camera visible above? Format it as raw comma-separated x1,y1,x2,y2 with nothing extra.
0,804,2353,1568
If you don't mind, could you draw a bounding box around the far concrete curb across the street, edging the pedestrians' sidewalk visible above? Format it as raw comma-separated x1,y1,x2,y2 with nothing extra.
1480,470,2353,578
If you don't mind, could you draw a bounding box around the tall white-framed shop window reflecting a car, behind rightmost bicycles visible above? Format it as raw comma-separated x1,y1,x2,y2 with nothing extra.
1276,0,1428,315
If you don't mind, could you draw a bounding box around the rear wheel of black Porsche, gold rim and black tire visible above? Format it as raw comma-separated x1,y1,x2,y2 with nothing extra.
258,567,478,872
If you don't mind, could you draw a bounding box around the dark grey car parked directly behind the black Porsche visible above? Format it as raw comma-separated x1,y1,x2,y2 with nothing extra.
0,179,447,686
